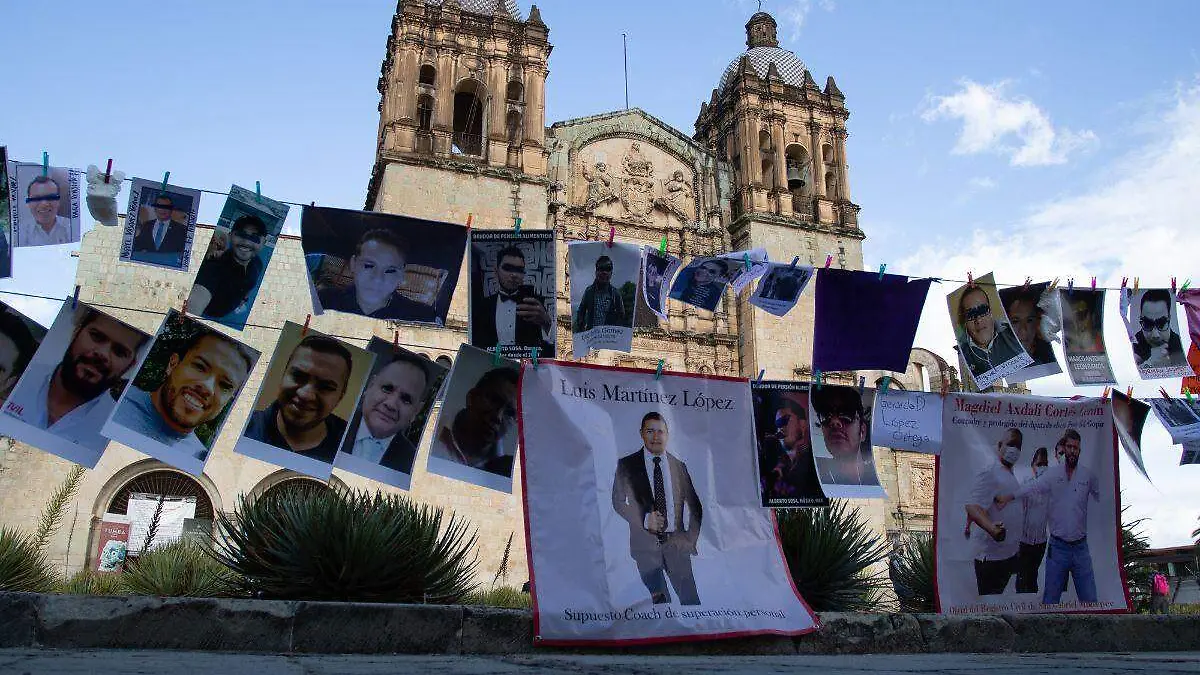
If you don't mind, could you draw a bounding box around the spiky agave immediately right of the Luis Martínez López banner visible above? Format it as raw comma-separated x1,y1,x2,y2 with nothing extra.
776,500,888,611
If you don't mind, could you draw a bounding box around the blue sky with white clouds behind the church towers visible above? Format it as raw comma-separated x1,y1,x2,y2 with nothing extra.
0,0,1200,545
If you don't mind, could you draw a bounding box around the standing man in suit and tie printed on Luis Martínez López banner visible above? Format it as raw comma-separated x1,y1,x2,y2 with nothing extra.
612,412,703,605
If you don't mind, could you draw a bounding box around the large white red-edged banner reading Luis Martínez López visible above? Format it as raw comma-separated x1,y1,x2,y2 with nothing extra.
521,362,816,645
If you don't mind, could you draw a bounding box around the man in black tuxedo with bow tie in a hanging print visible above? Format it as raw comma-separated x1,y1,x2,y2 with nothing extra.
470,246,554,358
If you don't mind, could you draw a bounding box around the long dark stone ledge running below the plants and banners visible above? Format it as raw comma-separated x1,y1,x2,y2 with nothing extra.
0,592,1200,656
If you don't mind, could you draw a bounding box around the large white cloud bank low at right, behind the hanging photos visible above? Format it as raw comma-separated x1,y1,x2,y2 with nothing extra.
896,74,1200,546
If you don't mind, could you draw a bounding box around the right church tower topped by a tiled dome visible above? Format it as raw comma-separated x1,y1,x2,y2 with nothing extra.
695,12,864,380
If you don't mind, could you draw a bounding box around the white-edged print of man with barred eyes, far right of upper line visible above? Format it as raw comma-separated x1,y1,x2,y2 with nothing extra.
1121,288,1195,380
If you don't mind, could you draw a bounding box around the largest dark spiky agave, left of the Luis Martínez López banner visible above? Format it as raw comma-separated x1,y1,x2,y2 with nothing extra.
212,490,478,603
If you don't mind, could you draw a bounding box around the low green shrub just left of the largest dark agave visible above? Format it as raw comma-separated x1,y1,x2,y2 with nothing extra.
121,539,235,598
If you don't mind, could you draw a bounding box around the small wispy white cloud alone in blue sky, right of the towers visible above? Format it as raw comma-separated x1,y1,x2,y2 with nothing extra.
922,79,1096,166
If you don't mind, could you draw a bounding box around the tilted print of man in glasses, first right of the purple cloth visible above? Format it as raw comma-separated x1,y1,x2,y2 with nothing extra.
954,283,1032,389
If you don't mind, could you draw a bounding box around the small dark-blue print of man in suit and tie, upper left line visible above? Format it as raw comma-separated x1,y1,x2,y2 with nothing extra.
121,178,200,271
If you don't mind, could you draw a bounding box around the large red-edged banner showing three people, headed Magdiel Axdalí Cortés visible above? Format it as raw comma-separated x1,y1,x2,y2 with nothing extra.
935,394,1129,614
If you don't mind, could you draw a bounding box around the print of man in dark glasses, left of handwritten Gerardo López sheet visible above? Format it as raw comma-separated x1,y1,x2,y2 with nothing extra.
809,384,887,498
